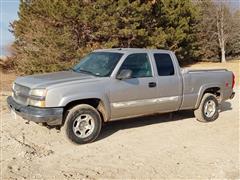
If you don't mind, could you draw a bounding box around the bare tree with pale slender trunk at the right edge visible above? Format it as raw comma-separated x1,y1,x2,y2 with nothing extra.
198,0,239,62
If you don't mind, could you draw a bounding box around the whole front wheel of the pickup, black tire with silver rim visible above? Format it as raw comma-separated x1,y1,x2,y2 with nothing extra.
63,104,102,144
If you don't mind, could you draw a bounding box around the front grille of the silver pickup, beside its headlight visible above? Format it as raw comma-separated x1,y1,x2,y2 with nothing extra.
13,84,30,105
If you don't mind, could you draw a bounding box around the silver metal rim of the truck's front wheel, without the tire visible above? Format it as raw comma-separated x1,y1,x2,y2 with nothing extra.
72,114,95,138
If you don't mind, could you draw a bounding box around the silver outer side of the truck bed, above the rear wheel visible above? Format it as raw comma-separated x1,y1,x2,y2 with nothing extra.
180,68,232,109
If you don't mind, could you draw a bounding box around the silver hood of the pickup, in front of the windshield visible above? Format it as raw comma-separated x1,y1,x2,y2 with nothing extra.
15,71,97,89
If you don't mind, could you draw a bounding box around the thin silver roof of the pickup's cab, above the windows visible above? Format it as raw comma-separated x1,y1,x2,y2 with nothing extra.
94,48,171,53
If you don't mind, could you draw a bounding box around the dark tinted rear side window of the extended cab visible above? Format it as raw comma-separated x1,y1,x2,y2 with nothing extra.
154,53,174,76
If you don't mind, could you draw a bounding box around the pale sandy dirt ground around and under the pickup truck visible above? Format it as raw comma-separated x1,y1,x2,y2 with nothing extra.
0,62,240,179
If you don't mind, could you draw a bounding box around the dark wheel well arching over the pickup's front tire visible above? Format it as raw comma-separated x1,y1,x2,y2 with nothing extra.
63,98,106,123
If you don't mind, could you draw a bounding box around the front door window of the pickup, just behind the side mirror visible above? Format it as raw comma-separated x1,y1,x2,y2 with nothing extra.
119,53,152,78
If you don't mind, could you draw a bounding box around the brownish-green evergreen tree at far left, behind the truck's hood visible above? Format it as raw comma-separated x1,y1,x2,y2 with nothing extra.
12,0,81,74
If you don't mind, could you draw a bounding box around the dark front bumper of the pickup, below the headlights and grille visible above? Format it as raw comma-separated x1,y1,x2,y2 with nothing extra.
7,96,63,126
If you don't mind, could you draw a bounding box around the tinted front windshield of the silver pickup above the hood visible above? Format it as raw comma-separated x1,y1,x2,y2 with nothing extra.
72,52,123,77
